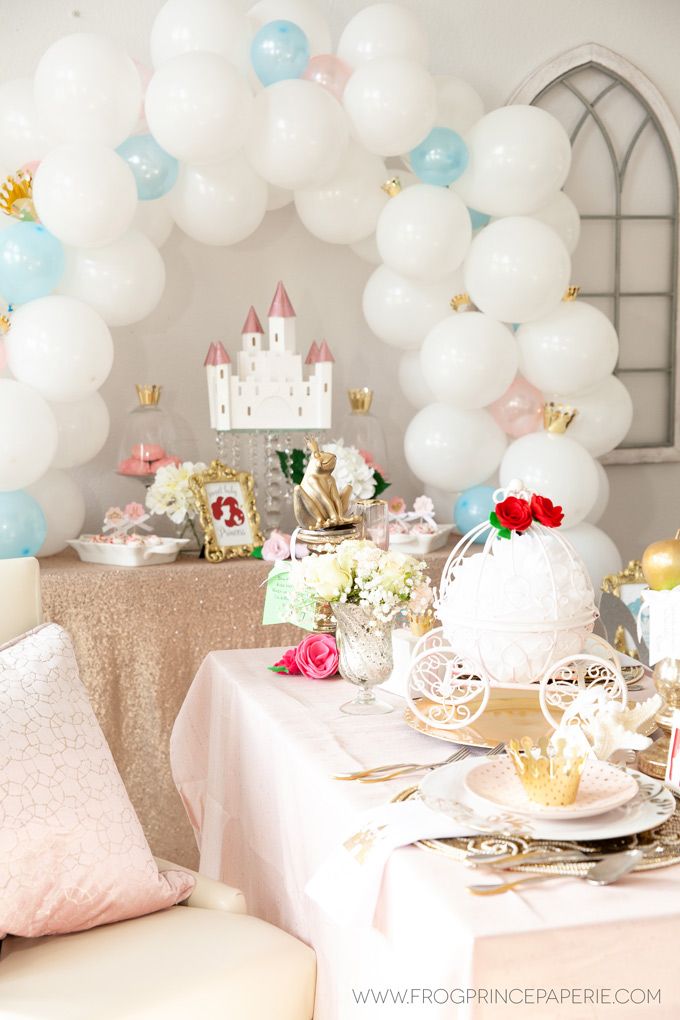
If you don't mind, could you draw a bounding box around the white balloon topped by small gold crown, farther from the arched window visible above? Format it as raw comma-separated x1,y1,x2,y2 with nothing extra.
420,312,518,410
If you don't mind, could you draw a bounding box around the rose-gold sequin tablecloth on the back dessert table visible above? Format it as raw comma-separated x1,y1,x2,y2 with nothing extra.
41,549,450,867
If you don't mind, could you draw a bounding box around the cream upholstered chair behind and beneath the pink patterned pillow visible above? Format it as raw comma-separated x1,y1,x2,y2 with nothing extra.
0,559,316,1020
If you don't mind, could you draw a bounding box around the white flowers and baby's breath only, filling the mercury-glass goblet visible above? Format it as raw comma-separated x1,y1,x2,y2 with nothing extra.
294,540,428,620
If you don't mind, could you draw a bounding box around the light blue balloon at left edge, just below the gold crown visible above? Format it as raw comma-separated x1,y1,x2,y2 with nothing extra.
0,221,65,305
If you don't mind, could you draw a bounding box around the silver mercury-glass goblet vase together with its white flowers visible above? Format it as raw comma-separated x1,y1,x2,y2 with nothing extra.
294,540,428,715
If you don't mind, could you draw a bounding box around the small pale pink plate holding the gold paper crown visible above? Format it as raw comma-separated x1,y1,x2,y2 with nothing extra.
464,755,638,821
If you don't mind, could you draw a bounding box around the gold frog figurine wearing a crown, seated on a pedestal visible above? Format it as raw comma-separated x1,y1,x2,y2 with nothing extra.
293,438,358,531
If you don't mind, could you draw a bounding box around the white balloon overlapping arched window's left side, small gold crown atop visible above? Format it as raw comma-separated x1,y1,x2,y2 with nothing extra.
517,301,619,394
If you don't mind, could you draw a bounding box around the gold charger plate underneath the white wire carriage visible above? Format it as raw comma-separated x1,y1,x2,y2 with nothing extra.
404,687,657,748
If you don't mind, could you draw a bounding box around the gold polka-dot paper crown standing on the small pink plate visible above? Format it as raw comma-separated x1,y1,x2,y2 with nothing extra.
508,736,587,808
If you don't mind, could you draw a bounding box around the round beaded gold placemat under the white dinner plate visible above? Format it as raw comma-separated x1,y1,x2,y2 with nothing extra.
394,786,680,876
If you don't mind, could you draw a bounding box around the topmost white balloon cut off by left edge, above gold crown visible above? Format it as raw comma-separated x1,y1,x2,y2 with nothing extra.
0,78,54,167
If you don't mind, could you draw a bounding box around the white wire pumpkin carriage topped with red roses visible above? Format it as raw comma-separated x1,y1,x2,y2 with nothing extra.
407,481,627,740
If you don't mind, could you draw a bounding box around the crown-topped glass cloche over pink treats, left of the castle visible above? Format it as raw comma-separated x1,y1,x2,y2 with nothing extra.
116,384,181,482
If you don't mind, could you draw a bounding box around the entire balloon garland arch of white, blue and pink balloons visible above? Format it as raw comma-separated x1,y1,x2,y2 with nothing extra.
0,0,632,579
